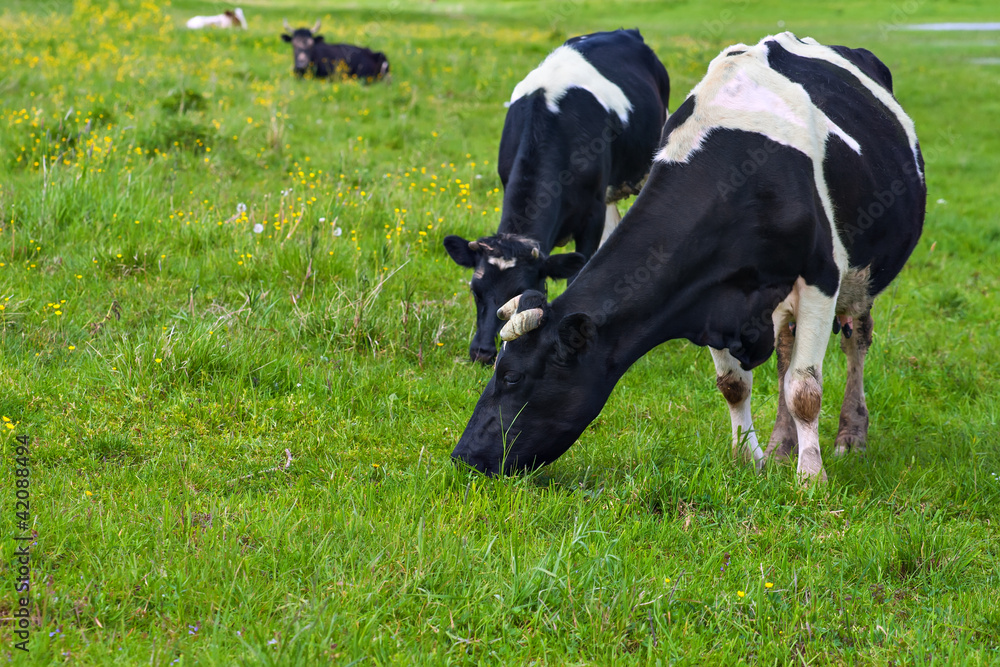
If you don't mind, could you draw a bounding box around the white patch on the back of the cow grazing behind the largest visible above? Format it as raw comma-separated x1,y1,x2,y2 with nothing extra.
507,45,632,125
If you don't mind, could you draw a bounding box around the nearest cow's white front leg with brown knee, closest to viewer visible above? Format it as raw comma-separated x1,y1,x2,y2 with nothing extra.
773,278,837,484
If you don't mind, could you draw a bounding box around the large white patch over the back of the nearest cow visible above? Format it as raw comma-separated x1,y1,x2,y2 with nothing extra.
656,38,861,276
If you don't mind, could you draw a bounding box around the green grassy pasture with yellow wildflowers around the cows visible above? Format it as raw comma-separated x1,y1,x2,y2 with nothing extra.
0,0,1000,665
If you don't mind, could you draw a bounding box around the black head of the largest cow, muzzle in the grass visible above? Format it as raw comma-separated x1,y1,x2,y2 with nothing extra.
451,292,614,475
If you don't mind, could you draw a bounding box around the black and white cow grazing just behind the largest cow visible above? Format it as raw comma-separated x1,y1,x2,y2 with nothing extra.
444,30,670,363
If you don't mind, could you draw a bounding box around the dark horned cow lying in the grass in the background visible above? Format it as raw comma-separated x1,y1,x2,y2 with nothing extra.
281,19,389,80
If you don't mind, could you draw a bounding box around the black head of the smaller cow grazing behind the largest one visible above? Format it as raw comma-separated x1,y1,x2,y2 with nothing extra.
444,234,587,364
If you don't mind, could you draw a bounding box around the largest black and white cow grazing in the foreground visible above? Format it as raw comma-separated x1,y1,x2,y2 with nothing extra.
452,32,927,482
